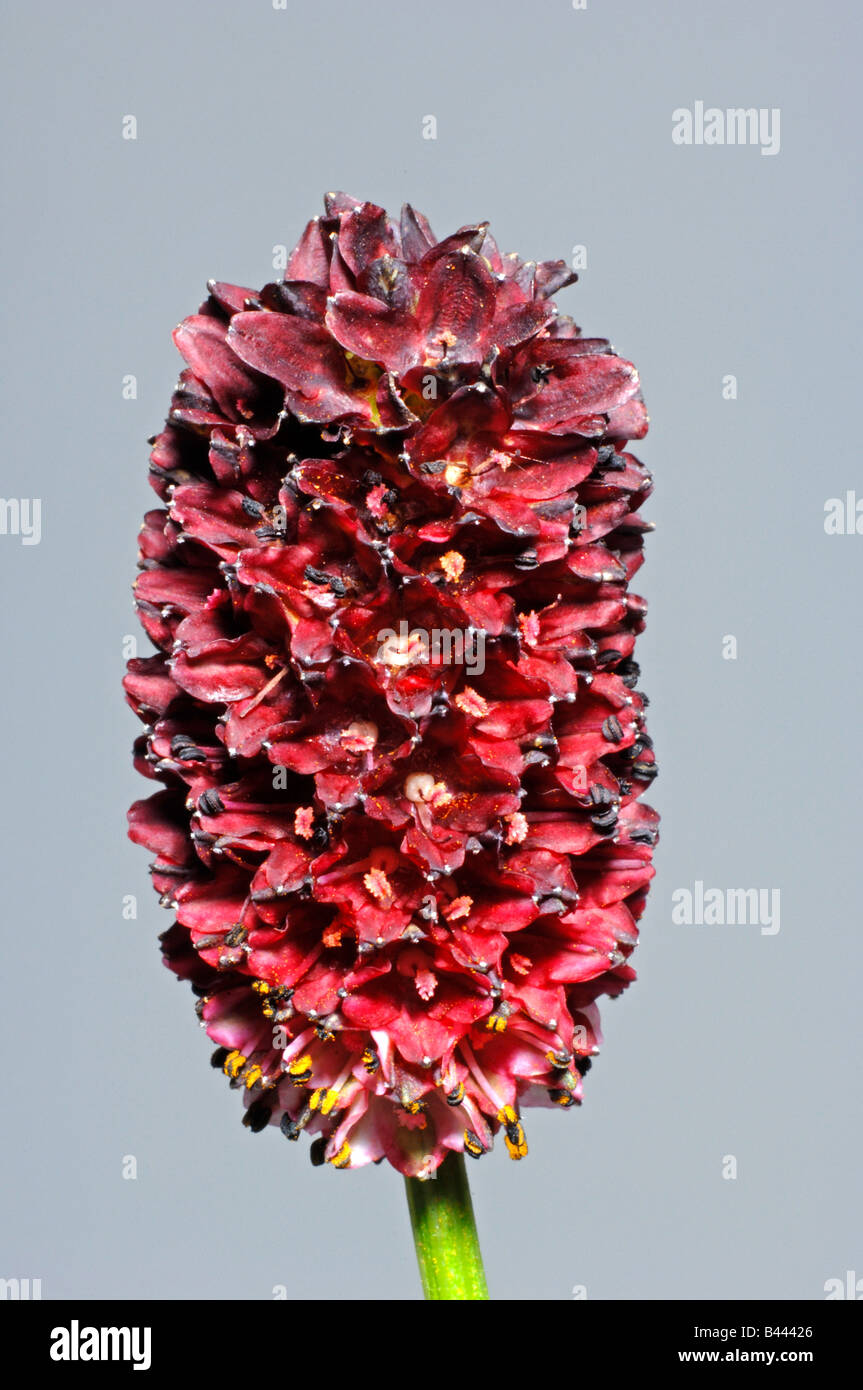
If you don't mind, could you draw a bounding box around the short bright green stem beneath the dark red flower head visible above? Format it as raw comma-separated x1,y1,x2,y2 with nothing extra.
404,1154,488,1301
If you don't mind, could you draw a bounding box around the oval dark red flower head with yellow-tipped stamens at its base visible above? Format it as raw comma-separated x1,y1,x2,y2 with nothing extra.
125,193,657,1176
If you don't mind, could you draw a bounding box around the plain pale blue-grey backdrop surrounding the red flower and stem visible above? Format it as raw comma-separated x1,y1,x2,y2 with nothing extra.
0,0,863,1300
